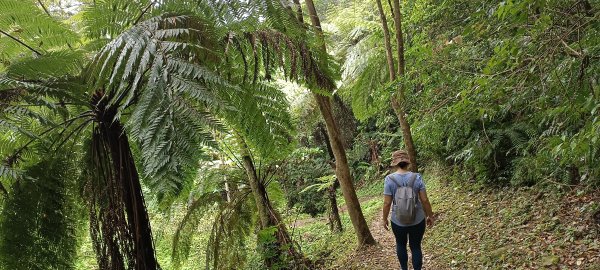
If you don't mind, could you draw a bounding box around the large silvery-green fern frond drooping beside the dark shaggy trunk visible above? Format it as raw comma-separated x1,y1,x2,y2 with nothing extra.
88,15,231,198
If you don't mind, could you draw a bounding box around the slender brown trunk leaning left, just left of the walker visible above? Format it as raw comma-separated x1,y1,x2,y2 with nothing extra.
306,0,376,246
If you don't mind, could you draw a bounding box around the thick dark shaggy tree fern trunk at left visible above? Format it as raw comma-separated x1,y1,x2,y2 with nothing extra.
88,92,159,270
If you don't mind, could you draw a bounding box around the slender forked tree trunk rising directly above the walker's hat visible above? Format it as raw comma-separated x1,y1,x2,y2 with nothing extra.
376,0,419,172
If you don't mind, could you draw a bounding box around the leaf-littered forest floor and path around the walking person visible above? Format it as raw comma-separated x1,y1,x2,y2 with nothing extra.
294,168,600,270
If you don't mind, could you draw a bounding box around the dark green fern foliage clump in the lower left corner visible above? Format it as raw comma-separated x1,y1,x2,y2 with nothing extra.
0,155,82,269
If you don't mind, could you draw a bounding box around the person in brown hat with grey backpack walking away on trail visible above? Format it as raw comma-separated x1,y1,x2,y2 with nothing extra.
383,150,434,270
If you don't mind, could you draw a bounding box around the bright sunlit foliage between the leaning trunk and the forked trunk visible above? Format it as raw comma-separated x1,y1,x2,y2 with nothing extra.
328,1,394,121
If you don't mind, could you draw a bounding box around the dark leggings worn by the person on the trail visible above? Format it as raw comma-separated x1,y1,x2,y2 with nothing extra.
392,219,425,270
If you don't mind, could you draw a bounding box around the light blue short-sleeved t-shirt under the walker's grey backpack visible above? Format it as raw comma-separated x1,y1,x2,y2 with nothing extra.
383,172,425,227
